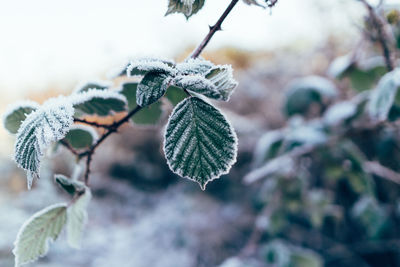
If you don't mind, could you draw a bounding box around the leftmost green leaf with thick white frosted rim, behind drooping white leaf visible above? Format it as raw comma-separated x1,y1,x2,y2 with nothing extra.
3,101,40,134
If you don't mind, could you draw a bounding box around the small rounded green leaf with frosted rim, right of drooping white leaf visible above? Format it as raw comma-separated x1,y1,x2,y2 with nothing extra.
63,125,98,149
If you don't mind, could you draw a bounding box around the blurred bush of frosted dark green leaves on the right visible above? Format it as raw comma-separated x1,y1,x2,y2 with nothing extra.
238,6,400,266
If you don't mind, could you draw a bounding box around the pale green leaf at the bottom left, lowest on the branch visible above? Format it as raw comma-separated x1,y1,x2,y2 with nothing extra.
13,203,67,267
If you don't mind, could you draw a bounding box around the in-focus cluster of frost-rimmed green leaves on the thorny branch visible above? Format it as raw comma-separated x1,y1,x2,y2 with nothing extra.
4,56,237,266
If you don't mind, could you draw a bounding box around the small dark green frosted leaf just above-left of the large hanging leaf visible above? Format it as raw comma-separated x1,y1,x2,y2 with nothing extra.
136,72,171,107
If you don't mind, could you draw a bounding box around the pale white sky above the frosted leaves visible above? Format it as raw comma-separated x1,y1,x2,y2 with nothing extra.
0,0,372,99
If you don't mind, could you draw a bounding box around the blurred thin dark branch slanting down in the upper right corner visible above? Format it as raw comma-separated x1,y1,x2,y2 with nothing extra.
360,0,395,71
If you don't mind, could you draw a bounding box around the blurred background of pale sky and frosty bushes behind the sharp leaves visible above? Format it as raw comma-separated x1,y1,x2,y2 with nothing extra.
0,0,400,267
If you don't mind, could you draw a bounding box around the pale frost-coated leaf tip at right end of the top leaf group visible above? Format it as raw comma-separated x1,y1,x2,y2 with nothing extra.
205,65,238,101
